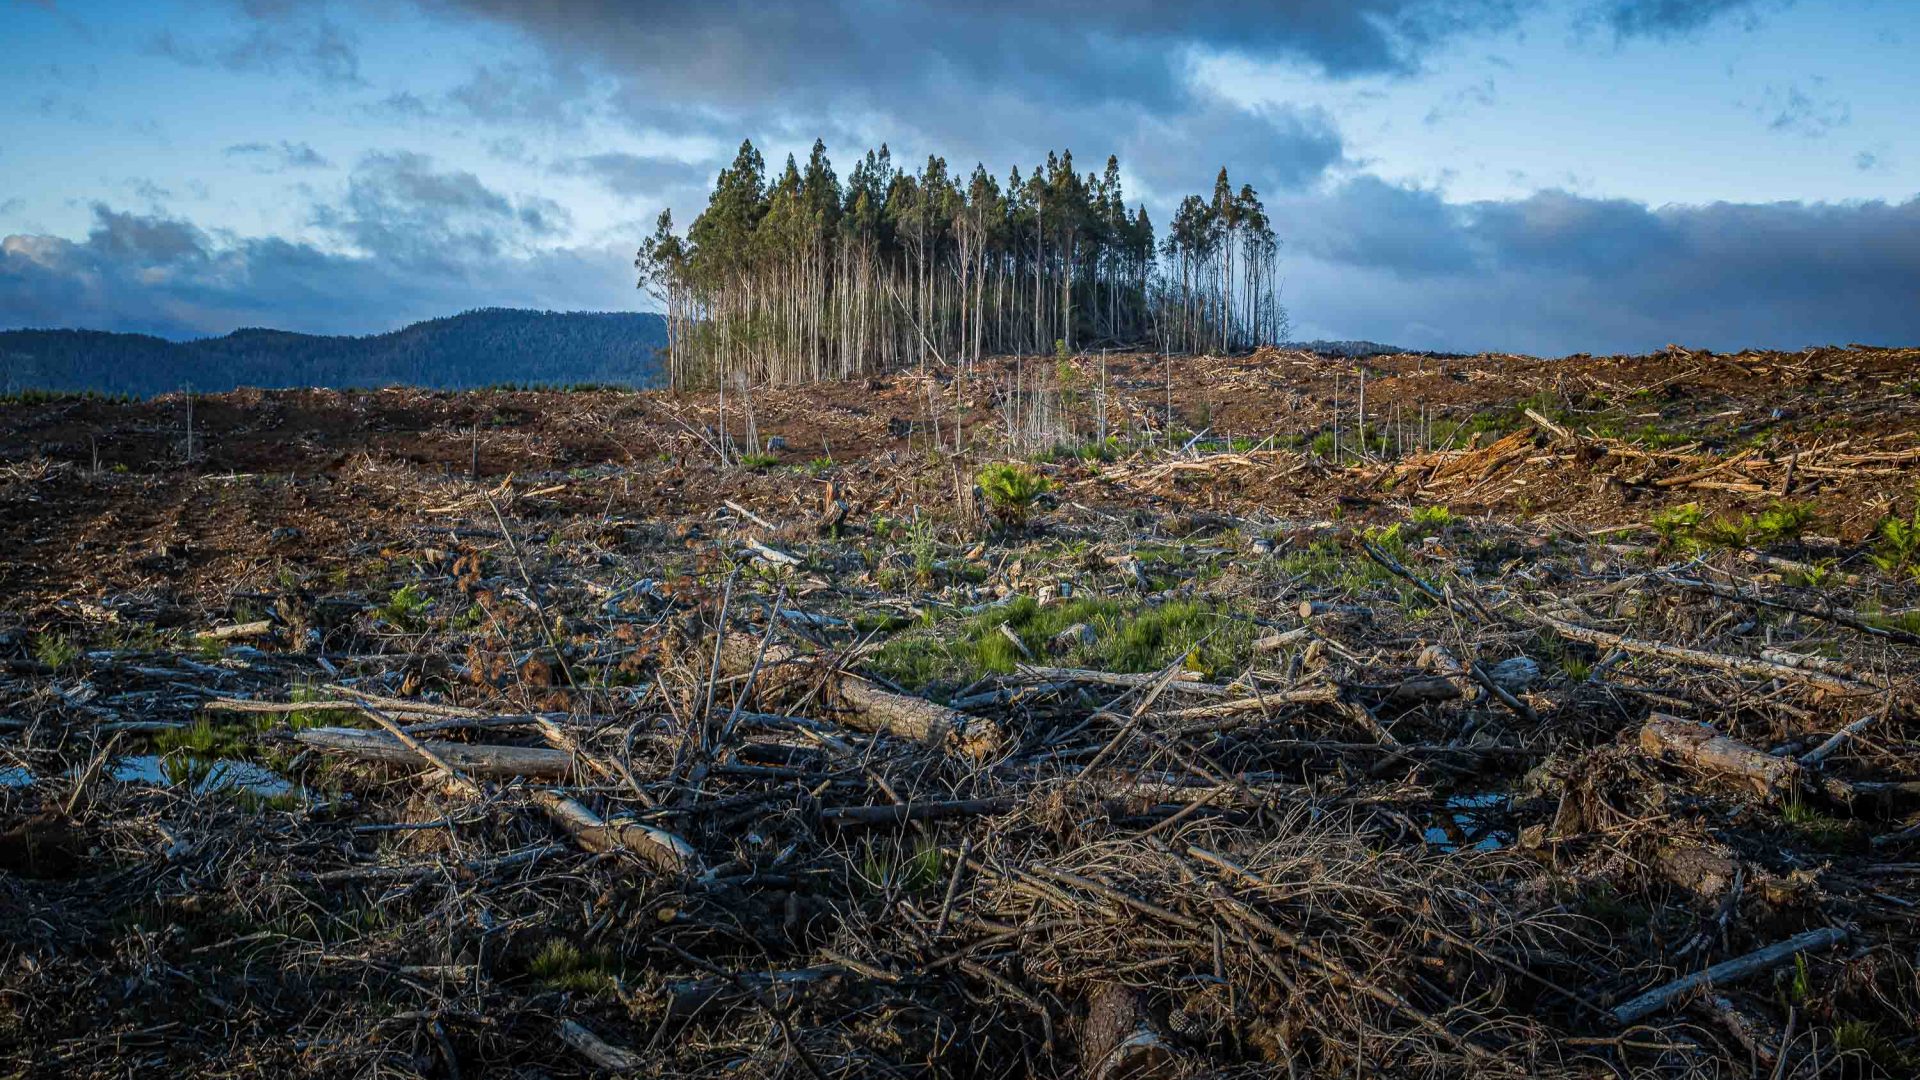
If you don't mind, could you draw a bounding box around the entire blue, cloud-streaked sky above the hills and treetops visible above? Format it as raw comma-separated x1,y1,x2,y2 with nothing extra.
0,0,1920,356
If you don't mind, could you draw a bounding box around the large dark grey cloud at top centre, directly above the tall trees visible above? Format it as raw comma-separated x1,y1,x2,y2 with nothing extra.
392,0,1497,195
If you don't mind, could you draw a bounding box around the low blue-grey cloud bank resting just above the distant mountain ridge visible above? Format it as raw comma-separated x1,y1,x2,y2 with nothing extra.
0,206,634,338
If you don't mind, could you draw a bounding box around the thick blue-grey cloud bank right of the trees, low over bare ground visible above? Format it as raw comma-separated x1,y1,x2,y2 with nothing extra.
1277,177,1920,356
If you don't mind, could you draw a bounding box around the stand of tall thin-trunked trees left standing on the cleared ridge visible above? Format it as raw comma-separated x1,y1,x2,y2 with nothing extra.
634,140,1286,386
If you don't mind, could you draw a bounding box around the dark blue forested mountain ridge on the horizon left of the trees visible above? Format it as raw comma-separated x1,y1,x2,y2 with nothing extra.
0,307,666,398
